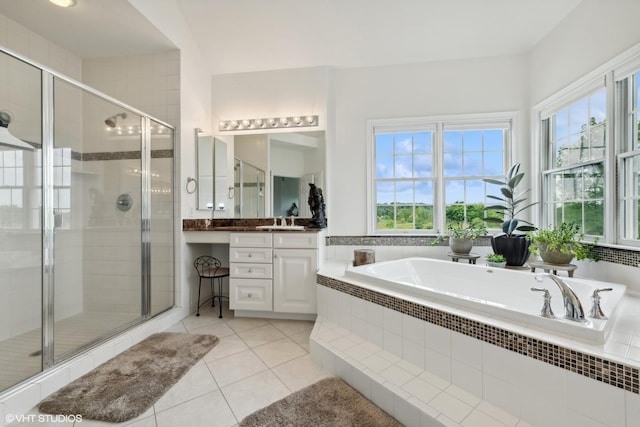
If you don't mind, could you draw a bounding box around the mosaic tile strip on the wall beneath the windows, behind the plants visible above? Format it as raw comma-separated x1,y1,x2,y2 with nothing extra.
326,236,640,267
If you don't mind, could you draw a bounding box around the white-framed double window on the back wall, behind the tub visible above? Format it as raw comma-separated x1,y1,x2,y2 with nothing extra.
369,116,511,233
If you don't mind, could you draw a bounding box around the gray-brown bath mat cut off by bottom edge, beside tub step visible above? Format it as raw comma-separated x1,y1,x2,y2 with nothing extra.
240,378,402,427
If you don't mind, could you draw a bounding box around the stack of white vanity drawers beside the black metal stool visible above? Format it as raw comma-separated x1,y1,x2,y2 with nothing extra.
229,232,273,311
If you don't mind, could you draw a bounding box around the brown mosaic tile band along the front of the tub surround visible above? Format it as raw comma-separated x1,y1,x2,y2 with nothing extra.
317,274,640,394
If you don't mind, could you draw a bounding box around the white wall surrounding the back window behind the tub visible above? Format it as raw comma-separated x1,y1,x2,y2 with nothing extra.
326,56,529,235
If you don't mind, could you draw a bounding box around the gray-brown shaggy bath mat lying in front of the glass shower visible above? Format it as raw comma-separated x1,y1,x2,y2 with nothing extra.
38,332,218,422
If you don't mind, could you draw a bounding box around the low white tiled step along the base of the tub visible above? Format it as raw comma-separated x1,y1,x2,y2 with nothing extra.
310,318,529,427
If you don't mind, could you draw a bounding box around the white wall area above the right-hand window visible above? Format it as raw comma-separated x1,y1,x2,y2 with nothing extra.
529,0,640,105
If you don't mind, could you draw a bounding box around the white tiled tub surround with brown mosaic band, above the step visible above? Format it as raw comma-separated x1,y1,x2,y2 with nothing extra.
318,263,640,426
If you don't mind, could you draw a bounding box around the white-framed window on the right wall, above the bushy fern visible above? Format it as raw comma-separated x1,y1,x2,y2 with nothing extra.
534,45,640,247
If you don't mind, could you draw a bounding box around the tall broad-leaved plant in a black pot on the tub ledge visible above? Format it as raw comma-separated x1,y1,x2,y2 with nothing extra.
484,163,536,266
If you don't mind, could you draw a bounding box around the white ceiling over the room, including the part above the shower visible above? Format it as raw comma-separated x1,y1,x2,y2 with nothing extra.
0,0,581,74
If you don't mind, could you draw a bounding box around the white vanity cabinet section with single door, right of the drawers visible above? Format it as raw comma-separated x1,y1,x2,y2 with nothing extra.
273,233,318,313
